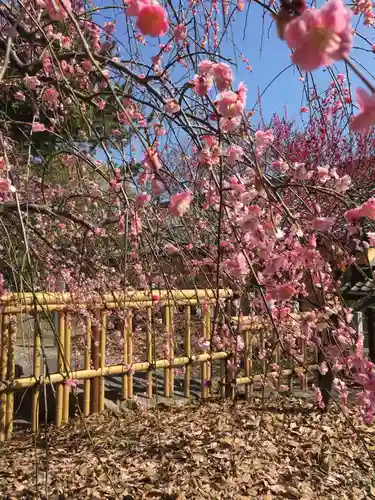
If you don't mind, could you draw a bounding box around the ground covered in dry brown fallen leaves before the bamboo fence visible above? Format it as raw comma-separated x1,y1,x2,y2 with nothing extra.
0,400,375,500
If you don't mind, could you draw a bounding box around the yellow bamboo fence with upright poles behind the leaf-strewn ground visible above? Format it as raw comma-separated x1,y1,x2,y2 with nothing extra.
0,289,316,442
